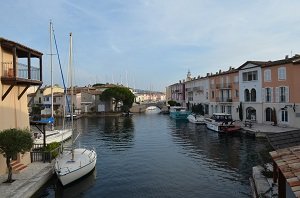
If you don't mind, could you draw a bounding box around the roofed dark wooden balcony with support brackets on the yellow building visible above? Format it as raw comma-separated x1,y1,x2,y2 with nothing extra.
0,38,43,100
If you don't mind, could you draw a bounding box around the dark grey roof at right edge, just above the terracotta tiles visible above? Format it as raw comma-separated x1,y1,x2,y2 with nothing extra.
267,130,300,150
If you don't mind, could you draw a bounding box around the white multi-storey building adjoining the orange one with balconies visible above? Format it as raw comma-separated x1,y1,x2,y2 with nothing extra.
185,72,209,114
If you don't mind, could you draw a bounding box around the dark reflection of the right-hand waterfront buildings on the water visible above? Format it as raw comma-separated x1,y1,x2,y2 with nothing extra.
171,117,270,184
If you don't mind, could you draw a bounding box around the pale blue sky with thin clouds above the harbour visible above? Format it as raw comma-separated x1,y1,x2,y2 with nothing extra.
0,0,300,91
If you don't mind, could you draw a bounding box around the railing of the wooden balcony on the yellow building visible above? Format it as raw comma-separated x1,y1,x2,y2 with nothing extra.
2,62,41,81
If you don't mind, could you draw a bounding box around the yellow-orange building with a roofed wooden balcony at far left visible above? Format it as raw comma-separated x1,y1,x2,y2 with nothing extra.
0,37,43,175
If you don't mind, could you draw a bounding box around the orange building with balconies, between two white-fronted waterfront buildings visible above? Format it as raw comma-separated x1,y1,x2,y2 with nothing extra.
208,67,240,120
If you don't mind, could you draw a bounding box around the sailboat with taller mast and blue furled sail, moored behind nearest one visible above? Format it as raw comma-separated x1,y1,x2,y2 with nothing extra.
34,21,72,144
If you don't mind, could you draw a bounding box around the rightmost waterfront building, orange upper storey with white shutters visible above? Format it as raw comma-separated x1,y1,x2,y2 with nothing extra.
261,55,300,128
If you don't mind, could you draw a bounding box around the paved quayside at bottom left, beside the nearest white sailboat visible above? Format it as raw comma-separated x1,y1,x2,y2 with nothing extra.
0,162,54,198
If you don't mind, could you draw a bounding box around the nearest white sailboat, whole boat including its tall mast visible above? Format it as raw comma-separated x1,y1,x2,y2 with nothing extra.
54,33,97,186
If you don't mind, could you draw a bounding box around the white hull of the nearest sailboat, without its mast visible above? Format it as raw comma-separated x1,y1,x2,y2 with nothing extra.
54,148,97,186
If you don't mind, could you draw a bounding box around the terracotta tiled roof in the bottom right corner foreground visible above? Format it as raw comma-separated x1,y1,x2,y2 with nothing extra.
270,146,300,197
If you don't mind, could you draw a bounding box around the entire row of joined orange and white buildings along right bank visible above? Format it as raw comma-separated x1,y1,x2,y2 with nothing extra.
167,55,300,128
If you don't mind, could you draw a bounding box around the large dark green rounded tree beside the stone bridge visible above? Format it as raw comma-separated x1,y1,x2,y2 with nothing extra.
100,87,135,109
